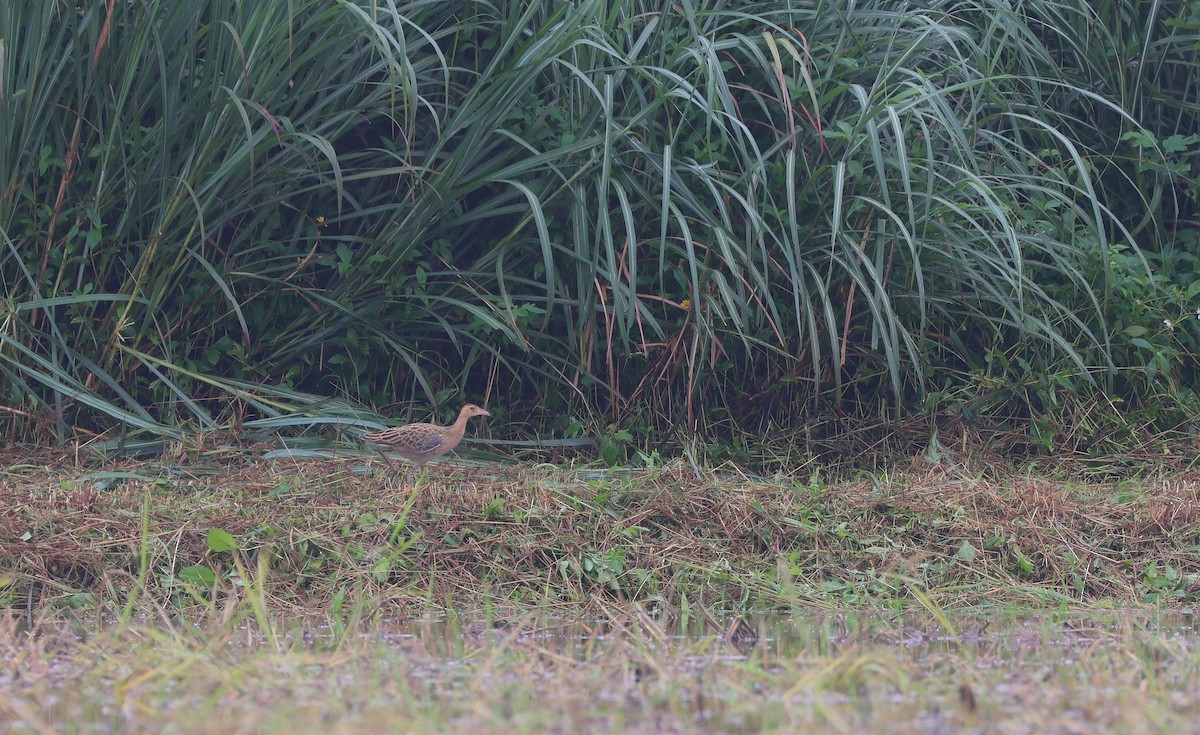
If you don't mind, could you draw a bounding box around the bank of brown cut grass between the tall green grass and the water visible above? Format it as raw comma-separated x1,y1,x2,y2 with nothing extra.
0,452,1200,617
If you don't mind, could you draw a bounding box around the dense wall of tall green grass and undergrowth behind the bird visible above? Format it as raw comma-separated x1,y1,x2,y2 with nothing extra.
0,0,1200,459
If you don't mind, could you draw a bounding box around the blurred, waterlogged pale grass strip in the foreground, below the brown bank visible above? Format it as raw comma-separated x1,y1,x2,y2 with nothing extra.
0,609,1200,735
